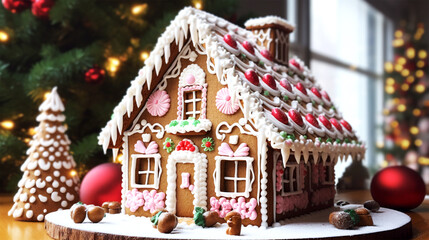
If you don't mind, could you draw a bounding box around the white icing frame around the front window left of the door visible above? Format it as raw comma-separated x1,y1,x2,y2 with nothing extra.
130,153,162,189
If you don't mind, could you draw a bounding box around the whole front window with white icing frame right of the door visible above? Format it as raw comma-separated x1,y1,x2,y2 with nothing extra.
214,156,255,198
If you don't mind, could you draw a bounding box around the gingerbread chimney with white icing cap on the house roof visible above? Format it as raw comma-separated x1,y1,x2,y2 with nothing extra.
244,16,294,65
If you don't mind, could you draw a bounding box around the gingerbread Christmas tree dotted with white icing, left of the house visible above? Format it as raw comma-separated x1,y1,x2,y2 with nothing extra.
9,87,79,221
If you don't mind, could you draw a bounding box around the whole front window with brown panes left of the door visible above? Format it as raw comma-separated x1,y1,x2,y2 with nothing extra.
131,153,162,189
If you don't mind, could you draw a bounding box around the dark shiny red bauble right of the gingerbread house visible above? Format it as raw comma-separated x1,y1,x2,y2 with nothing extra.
371,166,426,210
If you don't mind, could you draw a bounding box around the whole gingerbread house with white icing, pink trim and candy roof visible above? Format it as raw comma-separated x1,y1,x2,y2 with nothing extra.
99,8,365,226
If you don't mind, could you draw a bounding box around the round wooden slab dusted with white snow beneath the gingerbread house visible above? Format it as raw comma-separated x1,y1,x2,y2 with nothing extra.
45,205,412,240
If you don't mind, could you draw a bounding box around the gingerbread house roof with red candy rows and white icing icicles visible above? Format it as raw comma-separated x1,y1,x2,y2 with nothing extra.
99,7,365,164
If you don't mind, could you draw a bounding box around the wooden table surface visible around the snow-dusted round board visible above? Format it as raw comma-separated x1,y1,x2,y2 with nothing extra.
0,190,429,240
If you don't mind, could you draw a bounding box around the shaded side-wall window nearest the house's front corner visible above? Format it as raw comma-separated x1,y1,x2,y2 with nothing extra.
282,163,302,196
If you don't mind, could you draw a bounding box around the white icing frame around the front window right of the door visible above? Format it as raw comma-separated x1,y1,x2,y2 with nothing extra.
213,156,255,198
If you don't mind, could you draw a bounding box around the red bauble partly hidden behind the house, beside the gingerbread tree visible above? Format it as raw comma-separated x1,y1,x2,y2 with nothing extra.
80,163,122,206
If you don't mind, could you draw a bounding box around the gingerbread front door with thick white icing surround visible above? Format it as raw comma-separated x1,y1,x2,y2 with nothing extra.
165,139,208,217
